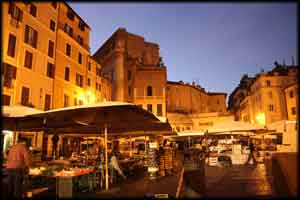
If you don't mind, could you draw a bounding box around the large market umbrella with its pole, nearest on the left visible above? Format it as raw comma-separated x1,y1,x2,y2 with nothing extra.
3,102,172,190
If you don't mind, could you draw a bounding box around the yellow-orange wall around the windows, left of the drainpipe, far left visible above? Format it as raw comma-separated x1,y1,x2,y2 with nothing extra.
2,2,57,110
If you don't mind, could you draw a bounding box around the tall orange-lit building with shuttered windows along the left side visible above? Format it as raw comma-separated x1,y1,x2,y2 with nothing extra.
1,2,111,158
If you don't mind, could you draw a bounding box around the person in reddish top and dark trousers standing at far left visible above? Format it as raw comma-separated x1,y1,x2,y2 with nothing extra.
6,138,31,198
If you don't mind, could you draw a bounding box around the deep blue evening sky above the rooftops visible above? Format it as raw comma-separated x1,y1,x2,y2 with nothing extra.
69,2,298,98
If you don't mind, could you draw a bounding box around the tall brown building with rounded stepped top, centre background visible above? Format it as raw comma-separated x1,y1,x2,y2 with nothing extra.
93,28,167,120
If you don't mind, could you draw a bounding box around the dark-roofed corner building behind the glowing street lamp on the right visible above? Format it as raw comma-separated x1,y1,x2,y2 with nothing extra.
233,65,298,125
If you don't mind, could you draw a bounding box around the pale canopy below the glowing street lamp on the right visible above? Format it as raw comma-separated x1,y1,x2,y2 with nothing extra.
207,121,266,133
